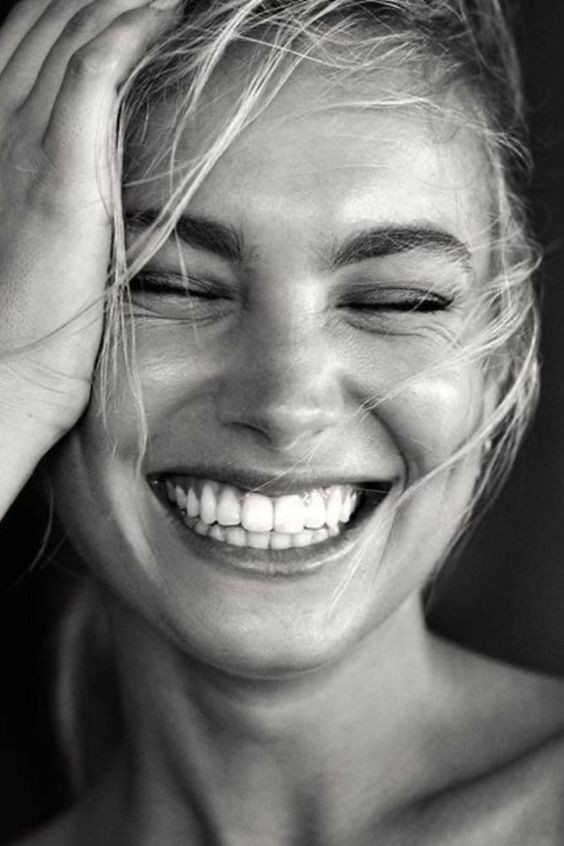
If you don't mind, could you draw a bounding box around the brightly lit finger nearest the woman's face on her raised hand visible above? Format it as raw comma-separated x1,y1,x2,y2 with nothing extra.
42,7,176,192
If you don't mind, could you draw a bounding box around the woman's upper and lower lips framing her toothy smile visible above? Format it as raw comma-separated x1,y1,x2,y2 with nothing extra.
147,467,393,578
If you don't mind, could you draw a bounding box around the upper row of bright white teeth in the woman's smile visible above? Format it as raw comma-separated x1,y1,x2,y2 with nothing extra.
165,476,359,535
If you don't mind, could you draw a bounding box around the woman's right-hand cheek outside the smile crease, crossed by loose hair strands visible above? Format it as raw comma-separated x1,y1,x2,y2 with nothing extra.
368,368,486,590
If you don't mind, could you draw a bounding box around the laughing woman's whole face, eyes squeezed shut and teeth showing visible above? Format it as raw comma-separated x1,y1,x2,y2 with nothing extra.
54,56,490,676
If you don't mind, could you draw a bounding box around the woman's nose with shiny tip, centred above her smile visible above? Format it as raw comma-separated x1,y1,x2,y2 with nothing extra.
218,319,345,452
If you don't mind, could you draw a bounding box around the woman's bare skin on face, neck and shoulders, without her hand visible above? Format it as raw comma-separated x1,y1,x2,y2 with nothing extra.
0,4,564,846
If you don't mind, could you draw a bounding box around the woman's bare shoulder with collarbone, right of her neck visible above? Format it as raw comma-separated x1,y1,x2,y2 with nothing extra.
415,642,564,846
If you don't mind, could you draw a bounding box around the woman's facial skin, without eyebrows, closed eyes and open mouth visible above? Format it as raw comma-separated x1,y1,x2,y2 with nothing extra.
50,63,494,677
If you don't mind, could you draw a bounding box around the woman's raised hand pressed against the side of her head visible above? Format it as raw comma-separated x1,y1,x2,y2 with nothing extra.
0,0,175,452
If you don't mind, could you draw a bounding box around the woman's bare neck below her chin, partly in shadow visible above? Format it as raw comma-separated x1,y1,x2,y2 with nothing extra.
88,600,436,846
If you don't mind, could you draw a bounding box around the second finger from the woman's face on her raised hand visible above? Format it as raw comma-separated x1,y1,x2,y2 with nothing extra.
20,0,165,125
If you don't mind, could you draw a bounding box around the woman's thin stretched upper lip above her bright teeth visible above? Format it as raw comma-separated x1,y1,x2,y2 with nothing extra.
148,465,395,496
